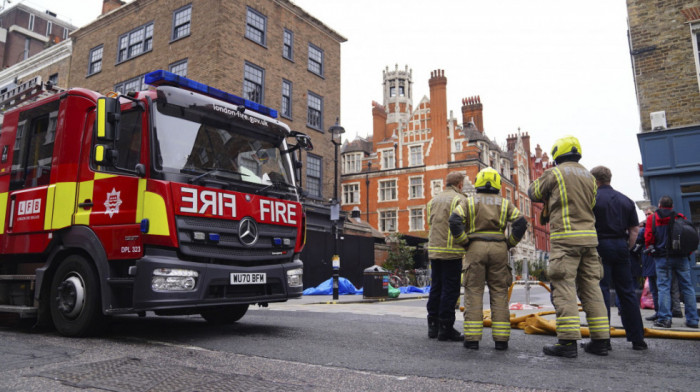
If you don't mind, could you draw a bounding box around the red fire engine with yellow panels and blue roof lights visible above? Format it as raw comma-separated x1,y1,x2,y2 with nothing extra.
0,71,312,336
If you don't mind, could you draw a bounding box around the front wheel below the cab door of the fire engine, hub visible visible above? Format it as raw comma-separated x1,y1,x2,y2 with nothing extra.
50,255,104,336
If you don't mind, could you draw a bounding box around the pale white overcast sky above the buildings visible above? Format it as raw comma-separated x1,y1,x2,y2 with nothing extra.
17,0,642,216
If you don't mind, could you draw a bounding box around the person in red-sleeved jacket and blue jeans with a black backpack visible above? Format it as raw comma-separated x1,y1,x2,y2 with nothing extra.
644,196,698,328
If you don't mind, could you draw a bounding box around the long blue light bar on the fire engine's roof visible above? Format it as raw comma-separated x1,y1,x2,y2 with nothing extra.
145,70,277,118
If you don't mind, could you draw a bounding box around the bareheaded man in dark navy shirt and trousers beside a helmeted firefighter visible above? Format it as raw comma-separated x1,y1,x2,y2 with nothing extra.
585,166,648,355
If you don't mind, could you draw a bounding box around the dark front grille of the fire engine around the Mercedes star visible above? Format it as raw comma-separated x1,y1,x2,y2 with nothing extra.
175,216,297,264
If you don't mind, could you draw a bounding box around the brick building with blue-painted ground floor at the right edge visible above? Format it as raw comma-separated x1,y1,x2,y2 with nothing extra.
627,0,700,233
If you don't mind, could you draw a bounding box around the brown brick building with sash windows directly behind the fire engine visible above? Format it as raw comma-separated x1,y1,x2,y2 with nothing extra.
69,0,346,202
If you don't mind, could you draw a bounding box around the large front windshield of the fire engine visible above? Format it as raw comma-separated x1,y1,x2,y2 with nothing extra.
154,88,294,190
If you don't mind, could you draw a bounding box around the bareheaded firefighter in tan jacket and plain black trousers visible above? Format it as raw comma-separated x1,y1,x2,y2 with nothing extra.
427,172,467,342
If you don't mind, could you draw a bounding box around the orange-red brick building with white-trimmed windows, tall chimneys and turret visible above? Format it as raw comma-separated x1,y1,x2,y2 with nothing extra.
341,66,548,259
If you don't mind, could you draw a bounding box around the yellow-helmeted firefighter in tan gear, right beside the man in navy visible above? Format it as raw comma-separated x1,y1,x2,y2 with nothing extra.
528,136,610,358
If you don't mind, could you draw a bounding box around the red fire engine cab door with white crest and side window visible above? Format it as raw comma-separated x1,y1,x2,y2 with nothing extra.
74,104,146,259
